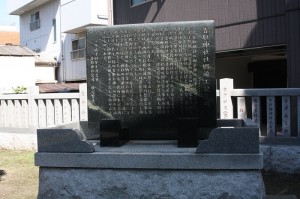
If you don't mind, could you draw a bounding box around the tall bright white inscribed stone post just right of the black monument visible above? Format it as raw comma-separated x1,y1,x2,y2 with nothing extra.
220,78,233,119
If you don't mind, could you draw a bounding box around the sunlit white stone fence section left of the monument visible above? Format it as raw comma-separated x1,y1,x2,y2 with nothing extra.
0,84,87,128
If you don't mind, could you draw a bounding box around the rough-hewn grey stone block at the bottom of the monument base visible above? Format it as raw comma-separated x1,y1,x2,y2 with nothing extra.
38,167,265,199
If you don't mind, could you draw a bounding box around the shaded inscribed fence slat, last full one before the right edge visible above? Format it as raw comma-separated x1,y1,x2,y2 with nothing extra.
282,96,291,137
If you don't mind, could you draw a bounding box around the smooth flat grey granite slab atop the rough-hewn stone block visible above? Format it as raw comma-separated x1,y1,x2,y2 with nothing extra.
35,141,263,170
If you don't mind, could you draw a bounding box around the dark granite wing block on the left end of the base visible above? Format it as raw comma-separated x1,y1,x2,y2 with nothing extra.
37,129,95,153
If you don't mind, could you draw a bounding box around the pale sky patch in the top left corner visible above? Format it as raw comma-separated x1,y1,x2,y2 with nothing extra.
0,0,20,30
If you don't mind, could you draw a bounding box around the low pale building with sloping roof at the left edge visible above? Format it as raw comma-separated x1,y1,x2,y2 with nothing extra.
0,45,56,92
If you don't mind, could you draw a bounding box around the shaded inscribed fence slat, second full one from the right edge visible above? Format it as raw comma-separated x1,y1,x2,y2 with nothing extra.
267,96,276,137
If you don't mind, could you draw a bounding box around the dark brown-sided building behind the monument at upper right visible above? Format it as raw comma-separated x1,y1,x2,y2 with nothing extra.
113,0,300,88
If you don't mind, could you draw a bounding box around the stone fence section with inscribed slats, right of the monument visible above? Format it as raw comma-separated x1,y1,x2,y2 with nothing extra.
217,79,300,137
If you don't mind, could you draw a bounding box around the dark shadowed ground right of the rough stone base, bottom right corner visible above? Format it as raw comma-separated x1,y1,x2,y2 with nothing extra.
262,171,300,198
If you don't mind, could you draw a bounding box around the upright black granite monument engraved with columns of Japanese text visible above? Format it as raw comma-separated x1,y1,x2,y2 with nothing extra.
86,21,216,146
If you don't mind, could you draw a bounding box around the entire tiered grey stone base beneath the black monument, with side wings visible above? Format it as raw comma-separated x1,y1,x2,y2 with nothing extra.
35,120,265,199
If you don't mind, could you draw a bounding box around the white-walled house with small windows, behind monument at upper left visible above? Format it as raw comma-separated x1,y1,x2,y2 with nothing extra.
8,0,112,82
